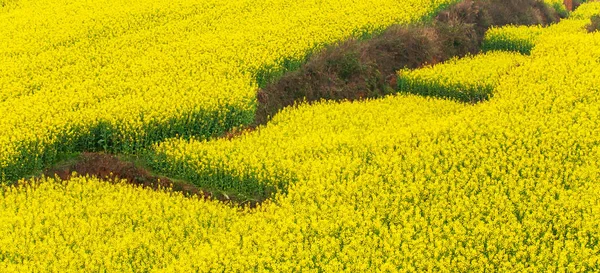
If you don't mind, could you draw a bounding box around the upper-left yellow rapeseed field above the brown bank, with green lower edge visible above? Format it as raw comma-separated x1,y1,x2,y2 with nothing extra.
0,0,456,181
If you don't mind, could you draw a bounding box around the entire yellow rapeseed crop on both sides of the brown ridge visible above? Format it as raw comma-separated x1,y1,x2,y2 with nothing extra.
0,0,600,272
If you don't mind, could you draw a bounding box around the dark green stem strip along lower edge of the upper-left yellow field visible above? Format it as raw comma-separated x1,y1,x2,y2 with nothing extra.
1,106,254,182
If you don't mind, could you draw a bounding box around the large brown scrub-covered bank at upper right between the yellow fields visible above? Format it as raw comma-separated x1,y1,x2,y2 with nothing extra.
253,0,566,126
